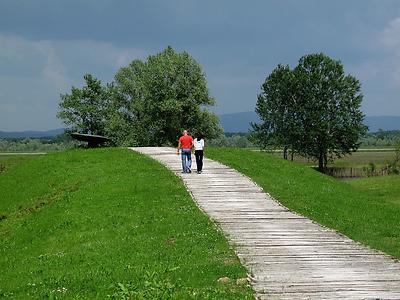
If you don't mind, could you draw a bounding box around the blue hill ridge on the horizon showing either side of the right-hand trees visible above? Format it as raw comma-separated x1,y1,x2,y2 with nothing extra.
219,111,400,132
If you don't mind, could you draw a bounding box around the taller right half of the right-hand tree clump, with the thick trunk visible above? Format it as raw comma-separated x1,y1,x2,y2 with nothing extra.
294,53,367,171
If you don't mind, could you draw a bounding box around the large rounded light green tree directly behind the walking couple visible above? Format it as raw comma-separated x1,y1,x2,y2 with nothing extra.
106,47,222,146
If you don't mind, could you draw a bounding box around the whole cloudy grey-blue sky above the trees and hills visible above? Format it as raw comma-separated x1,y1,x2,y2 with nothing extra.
0,0,400,131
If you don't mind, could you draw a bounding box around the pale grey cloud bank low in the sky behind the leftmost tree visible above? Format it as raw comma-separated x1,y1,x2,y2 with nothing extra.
0,34,144,131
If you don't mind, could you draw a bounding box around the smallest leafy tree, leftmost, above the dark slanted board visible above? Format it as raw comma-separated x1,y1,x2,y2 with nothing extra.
57,74,110,135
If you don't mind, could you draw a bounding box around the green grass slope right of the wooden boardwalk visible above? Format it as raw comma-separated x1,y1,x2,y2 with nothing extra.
205,148,400,258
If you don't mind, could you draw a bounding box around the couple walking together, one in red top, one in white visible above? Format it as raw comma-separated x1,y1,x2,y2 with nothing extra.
177,130,204,174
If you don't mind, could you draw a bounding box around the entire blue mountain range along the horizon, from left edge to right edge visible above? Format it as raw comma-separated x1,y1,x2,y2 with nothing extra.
0,111,400,139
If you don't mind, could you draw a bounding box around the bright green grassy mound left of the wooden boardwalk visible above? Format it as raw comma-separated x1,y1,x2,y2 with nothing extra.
0,149,253,299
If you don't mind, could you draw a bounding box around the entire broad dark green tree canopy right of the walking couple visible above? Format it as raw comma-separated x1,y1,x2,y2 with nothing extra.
253,53,367,170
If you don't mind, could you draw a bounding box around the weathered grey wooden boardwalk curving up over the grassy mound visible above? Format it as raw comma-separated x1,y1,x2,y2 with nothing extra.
133,148,400,299
